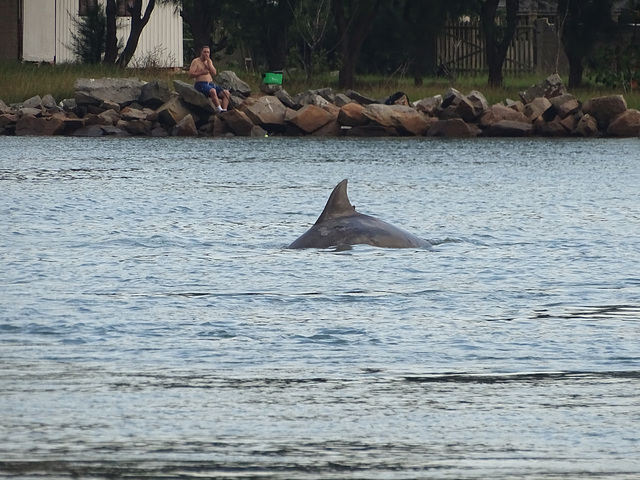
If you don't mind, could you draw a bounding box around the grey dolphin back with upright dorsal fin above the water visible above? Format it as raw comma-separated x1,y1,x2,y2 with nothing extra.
289,178,431,248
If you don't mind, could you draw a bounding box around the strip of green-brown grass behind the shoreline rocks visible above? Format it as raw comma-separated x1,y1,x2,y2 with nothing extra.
0,62,640,110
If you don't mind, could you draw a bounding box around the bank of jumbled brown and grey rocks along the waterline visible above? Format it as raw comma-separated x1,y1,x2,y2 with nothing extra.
0,71,640,137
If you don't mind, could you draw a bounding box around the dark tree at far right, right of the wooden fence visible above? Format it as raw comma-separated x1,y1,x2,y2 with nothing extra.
558,0,614,88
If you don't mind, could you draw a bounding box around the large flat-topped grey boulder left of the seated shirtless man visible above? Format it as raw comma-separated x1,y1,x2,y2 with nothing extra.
75,77,144,107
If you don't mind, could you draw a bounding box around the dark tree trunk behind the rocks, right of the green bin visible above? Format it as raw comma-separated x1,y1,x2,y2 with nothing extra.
331,0,381,88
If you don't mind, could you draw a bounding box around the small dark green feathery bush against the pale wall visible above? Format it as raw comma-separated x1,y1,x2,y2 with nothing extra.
70,4,107,64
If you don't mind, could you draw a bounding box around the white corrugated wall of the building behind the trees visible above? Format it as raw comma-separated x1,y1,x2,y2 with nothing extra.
23,0,183,68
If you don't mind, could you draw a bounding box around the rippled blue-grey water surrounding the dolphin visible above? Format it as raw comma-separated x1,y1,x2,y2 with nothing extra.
0,137,640,479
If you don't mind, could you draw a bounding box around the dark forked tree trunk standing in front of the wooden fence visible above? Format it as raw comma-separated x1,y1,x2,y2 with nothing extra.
479,0,520,87
